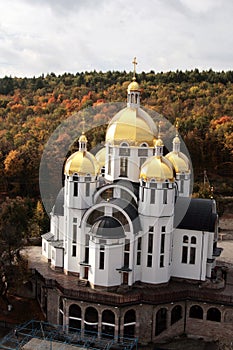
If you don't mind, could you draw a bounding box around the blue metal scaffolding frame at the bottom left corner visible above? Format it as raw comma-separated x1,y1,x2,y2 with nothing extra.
0,320,138,350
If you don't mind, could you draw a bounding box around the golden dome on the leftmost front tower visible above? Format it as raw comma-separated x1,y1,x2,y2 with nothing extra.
64,151,99,176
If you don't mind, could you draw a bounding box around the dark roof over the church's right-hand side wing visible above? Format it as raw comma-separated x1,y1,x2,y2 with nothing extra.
174,197,217,232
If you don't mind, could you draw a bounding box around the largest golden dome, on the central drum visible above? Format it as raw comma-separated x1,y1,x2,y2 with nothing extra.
106,107,156,146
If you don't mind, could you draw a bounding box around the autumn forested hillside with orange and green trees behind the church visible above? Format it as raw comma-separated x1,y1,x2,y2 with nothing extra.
0,69,233,241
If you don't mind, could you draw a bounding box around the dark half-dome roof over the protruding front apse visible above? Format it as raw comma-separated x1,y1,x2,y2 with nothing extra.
91,216,125,239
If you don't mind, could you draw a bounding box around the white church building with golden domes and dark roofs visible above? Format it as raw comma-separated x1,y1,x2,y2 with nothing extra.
42,63,218,290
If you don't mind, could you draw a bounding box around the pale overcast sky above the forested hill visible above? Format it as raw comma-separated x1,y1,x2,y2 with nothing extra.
0,0,233,77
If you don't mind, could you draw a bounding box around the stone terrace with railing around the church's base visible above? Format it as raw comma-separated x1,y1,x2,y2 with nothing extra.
25,247,233,305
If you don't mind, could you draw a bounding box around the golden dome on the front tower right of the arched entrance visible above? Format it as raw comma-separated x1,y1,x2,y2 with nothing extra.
140,156,173,181
